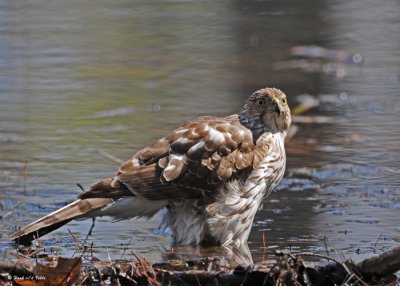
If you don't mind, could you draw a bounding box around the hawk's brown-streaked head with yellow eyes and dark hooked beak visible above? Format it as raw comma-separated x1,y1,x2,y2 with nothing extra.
241,88,291,133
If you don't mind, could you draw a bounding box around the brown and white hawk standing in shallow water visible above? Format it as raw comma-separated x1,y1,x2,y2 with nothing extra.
10,88,291,245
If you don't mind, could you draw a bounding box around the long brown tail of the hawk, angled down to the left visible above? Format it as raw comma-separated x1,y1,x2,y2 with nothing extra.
10,198,113,245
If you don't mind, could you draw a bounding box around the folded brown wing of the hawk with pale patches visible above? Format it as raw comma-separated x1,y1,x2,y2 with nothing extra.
85,115,269,200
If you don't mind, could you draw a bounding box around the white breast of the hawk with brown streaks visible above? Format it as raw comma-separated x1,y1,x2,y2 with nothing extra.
207,132,285,245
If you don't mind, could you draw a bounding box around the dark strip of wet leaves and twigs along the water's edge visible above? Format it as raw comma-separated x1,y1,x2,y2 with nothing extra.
0,247,400,286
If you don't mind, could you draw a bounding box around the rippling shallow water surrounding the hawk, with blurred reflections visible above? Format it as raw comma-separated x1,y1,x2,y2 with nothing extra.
0,0,400,262
